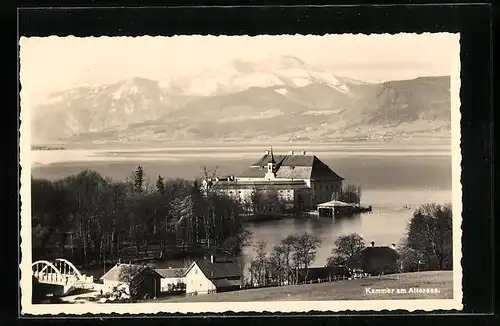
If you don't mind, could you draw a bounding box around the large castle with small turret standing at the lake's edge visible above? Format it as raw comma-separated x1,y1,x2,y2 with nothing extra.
203,148,344,210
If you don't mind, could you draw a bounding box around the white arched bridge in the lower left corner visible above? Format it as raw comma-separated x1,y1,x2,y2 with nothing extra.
31,258,94,294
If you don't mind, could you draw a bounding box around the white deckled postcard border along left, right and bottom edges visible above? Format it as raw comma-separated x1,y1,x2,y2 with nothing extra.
19,33,463,315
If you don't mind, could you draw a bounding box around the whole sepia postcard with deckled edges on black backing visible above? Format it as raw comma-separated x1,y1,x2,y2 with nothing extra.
19,33,462,315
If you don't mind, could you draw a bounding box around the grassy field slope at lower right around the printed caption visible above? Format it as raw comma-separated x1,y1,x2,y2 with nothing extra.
156,271,453,302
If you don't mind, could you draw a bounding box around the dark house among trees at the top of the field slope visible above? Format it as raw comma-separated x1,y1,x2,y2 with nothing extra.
346,241,400,275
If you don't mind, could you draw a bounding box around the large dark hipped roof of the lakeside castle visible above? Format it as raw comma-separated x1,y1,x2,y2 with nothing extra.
240,154,343,180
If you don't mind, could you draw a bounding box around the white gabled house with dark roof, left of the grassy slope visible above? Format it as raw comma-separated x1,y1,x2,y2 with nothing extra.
184,256,243,294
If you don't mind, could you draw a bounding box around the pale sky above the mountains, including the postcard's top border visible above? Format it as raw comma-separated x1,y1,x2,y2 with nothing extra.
20,33,459,101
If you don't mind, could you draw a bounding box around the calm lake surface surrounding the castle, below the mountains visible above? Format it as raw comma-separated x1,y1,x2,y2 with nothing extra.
31,144,452,266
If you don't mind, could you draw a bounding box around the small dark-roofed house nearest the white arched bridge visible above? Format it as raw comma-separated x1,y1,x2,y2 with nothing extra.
101,264,163,298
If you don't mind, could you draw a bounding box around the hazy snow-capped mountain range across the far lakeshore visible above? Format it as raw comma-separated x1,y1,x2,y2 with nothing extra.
30,56,451,143
